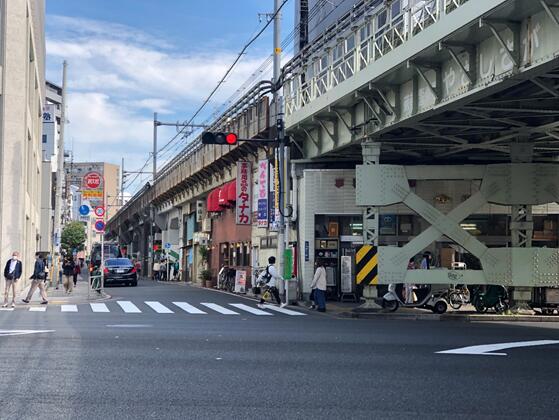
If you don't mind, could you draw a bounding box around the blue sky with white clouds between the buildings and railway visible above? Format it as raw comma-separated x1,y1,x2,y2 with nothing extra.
46,0,295,192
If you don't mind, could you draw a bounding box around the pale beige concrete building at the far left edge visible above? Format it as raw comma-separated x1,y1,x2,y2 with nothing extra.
0,0,45,290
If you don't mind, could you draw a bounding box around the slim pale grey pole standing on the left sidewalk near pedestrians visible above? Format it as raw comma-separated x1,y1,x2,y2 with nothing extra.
51,60,68,285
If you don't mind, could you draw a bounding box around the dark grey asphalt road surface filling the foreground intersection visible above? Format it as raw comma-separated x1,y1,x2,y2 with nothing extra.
0,282,559,419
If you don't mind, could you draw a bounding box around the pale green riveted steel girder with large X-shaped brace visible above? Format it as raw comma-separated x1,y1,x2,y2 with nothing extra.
357,163,559,287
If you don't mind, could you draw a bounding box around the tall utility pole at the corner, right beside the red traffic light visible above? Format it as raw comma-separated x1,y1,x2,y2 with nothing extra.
272,0,289,303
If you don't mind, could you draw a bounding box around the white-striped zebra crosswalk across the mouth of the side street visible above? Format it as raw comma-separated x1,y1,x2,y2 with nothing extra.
1,300,306,316
